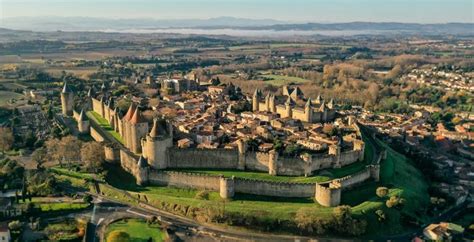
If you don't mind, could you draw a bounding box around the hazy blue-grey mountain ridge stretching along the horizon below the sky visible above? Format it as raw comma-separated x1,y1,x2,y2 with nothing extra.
0,17,474,35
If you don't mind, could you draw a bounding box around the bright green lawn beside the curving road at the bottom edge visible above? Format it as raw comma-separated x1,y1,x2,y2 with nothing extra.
106,219,166,242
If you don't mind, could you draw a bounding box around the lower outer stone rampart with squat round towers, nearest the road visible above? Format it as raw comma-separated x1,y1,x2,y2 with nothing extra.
120,151,381,207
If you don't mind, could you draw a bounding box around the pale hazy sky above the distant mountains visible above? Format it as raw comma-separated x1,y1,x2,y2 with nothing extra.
0,0,474,23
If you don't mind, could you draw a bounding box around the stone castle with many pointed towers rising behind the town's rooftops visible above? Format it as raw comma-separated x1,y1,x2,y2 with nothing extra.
252,86,336,123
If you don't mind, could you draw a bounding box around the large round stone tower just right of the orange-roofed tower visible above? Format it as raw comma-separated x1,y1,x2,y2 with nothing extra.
142,119,173,169
